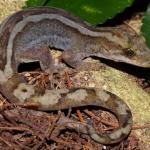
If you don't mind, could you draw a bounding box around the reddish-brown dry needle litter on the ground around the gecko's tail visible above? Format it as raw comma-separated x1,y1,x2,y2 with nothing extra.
0,71,139,150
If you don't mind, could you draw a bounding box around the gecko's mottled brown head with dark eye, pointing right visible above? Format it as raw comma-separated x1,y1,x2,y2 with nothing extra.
106,25,150,68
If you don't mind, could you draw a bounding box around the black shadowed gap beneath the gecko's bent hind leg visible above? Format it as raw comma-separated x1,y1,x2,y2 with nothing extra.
17,61,42,73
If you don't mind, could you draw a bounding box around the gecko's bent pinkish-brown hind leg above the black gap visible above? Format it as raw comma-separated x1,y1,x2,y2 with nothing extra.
15,44,54,74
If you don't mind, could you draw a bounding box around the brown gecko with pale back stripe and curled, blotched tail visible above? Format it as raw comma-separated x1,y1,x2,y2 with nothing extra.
0,7,150,144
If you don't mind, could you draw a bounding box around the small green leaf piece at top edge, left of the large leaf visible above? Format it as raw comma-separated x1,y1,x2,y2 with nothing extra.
26,0,47,7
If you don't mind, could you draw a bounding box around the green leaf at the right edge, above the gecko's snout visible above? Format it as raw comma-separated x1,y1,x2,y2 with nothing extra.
141,4,150,47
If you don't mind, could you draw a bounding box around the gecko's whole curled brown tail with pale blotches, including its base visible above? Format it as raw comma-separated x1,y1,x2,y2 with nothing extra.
1,77,132,144
